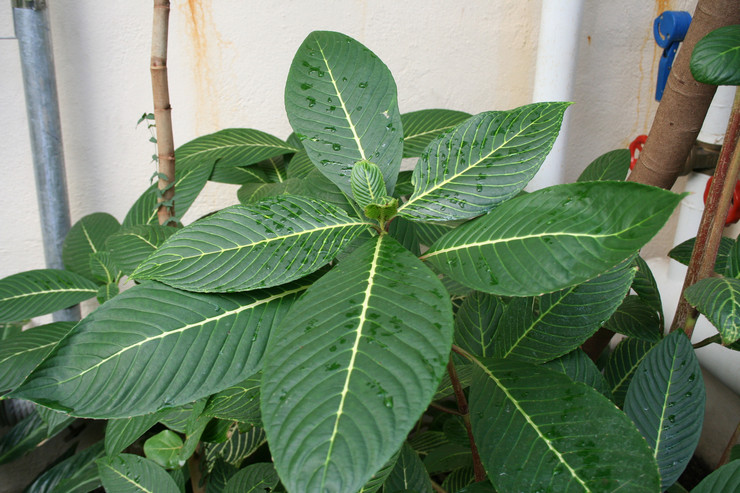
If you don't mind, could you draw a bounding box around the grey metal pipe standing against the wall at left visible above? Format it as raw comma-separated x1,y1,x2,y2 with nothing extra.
11,0,80,321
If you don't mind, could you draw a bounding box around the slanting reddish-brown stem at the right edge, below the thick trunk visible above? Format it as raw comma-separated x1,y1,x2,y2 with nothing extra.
671,93,740,338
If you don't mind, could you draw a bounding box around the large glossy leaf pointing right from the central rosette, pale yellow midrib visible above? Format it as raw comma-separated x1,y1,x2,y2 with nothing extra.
422,181,681,296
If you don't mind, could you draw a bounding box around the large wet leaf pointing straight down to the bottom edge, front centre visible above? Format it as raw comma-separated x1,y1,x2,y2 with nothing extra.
262,235,453,493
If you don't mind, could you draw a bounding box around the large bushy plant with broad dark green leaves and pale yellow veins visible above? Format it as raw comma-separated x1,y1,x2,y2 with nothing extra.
0,28,732,493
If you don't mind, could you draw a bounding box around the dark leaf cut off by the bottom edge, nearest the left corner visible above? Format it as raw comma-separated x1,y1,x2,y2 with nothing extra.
24,442,104,493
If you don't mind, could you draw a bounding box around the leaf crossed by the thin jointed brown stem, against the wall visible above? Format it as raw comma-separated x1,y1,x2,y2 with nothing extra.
123,159,214,227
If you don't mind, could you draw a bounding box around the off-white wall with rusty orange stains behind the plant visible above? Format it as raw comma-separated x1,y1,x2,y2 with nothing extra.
0,0,695,277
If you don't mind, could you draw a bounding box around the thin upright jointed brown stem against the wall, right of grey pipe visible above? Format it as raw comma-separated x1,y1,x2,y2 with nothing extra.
150,0,175,224
